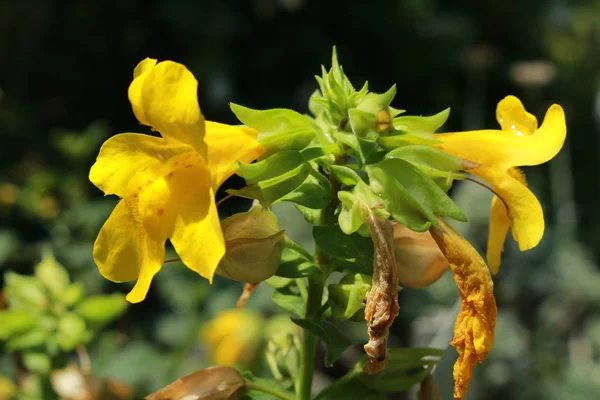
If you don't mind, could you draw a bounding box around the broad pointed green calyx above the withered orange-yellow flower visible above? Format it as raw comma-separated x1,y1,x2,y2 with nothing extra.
366,158,467,232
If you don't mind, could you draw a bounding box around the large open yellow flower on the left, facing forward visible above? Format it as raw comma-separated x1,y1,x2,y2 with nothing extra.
90,58,263,303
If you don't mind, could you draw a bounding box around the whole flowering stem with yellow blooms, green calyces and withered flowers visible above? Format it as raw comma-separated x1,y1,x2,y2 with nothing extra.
90,53,566,400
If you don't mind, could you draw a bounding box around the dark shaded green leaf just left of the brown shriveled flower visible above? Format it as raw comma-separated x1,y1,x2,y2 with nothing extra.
313,225,373,271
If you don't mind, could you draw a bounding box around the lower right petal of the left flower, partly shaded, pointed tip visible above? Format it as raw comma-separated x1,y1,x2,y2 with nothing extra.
164,168,225,282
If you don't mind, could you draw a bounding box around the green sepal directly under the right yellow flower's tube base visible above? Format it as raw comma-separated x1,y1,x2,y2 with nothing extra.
386,145,467,191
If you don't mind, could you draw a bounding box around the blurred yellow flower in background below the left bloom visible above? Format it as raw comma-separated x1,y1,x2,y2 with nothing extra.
200,308,263,367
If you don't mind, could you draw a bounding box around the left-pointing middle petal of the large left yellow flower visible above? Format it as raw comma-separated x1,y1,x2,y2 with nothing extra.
90,133,191,197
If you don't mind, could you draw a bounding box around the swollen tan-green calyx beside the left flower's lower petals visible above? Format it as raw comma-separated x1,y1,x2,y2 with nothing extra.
217,207,284,283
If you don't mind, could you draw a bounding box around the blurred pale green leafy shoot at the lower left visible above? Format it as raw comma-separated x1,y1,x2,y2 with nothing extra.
0,249,127,375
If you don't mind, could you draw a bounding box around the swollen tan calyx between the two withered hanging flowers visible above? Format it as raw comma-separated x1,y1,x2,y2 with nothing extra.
394,223,450,289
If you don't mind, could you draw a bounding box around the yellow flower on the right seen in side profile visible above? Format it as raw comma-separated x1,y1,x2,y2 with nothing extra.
435,96,567,274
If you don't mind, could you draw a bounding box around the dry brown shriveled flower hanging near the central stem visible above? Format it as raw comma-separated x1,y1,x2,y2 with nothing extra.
364,213,399,374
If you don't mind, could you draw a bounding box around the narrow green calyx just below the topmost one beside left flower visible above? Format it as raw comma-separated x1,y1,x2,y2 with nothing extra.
237,150,305,184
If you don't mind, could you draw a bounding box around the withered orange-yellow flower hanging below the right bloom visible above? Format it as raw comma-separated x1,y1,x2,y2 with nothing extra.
430,218,498,399
